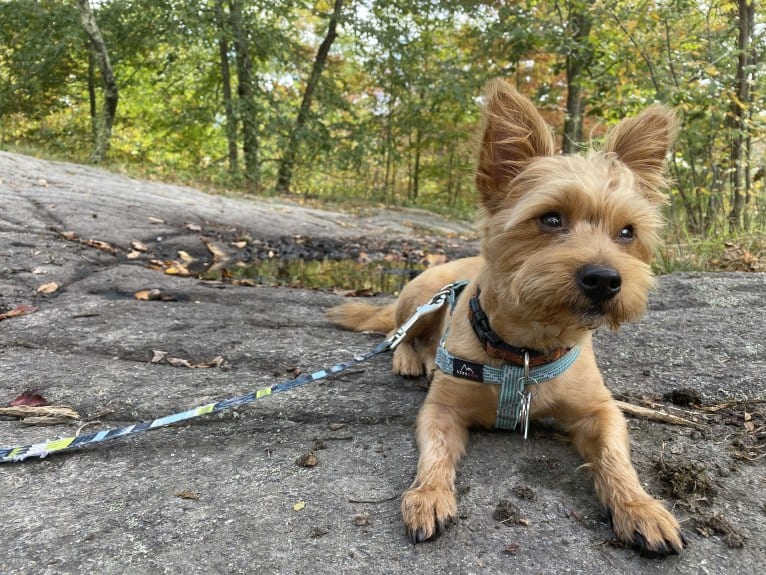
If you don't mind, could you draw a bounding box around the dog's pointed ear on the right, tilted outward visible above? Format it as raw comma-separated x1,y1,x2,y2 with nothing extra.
604,104,678,203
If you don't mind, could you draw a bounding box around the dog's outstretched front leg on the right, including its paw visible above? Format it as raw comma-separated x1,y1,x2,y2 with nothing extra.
568,399,684,555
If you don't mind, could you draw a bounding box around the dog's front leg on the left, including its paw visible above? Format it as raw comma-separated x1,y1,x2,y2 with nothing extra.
402,398,468,543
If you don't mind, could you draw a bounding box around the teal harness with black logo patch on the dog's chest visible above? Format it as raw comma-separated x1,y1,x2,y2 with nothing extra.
436,283,580,439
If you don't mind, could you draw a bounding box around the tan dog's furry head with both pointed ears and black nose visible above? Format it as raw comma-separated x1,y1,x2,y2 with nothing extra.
476,80,677,336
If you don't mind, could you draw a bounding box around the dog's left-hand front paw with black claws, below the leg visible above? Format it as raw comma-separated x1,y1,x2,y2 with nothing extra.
402,485,457,543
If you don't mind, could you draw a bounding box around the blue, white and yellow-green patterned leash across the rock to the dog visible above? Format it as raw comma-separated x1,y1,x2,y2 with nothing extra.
0,281,468,463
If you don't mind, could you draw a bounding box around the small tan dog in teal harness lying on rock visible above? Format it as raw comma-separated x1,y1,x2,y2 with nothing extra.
327,80,684,555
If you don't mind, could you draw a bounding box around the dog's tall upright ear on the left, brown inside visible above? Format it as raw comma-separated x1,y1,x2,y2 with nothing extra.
476,78,554,214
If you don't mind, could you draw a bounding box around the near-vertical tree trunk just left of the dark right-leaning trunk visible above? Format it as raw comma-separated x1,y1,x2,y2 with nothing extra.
229,0,261,191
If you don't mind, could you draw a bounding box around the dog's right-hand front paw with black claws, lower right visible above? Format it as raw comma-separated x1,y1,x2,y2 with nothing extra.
608,497,686,556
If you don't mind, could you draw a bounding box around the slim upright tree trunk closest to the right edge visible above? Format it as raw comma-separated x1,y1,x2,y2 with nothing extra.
729,0,755,230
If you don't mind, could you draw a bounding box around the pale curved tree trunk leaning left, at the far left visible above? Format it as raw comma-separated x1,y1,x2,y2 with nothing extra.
77,0,119,163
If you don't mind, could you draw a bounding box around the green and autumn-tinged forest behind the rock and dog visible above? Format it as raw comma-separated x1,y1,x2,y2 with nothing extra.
0,0,766,270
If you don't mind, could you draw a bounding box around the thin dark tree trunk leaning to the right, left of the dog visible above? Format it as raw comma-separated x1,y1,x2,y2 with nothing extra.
276,0,343,194
